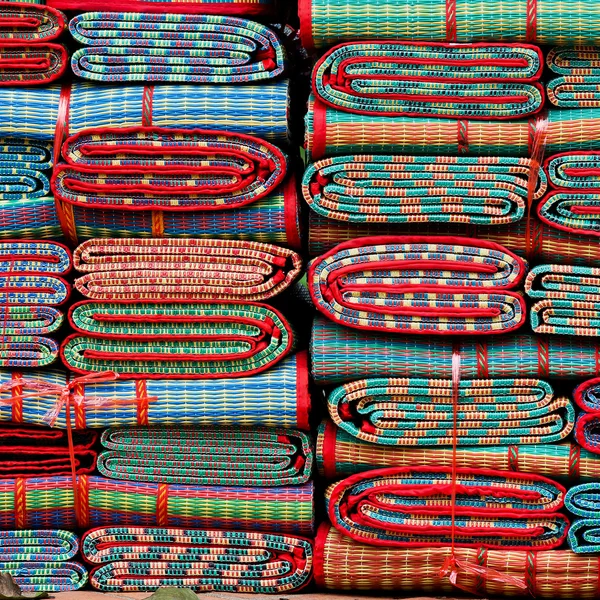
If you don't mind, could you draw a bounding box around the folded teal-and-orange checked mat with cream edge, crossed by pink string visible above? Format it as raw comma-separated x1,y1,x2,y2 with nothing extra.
327,377,575,446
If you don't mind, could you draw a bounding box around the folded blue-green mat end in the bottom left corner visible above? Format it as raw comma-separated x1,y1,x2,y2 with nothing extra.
0,529,88,592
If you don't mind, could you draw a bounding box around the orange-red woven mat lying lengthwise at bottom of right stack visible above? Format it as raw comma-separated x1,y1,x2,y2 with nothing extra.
315,523,600,600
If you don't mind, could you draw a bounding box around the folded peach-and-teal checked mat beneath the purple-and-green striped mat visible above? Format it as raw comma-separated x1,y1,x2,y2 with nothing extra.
82,527,313,594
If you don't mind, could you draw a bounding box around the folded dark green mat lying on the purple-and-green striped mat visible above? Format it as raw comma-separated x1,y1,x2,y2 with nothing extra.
98,427,313,487
